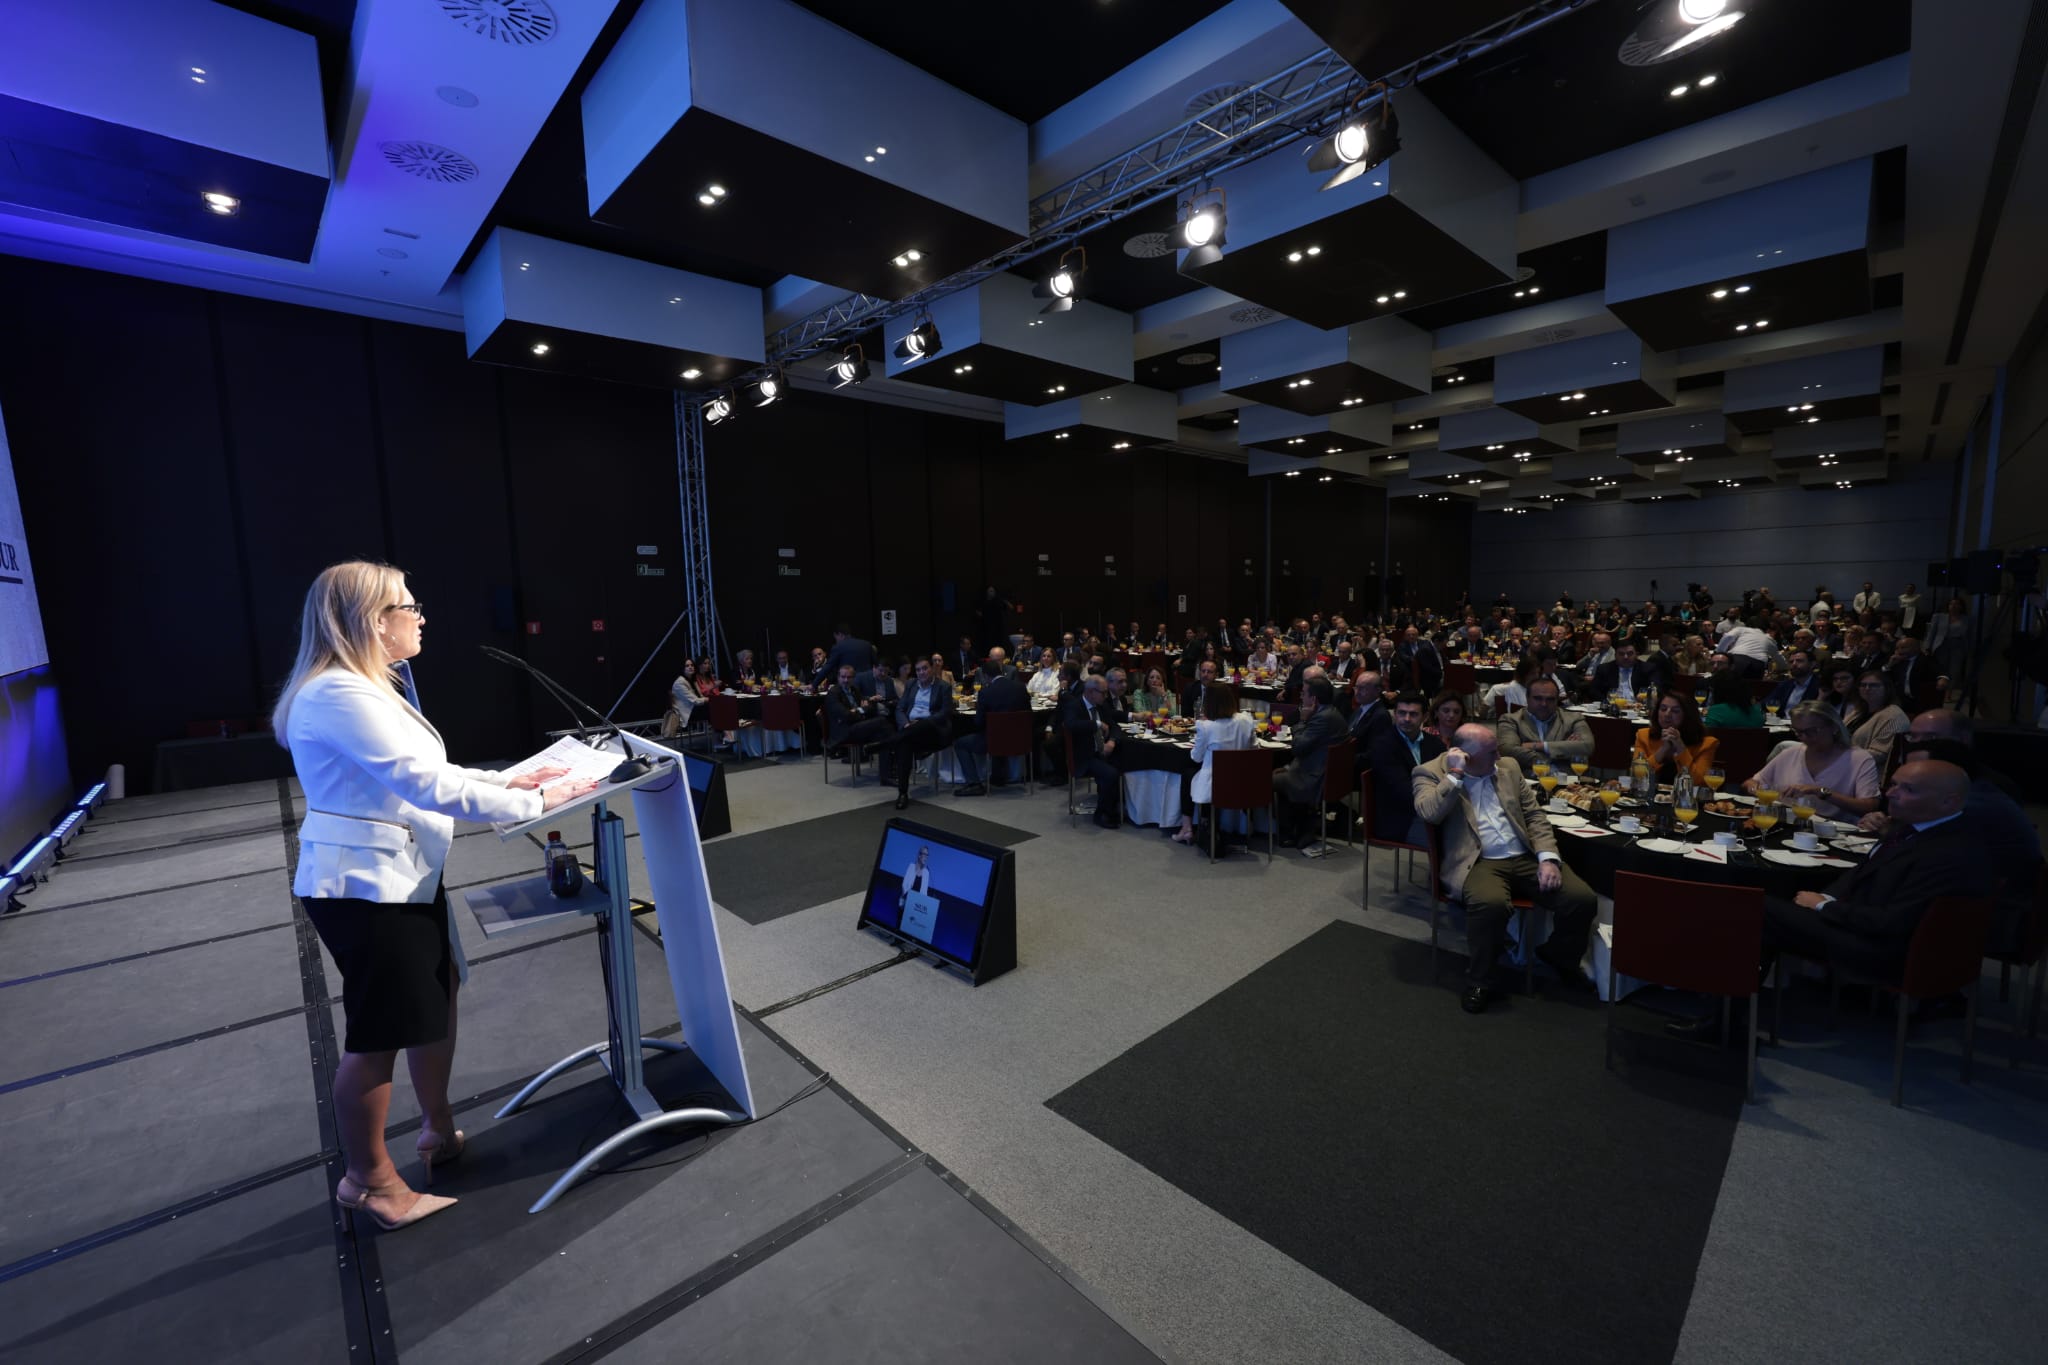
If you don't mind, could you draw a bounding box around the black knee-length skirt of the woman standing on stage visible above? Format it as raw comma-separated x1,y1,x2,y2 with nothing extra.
303,890,455,1052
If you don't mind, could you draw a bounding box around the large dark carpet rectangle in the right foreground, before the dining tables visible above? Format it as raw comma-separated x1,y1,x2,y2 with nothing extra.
1049,925,1743,1365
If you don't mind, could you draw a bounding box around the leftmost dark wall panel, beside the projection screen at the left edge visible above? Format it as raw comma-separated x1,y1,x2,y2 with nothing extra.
0,258,256,784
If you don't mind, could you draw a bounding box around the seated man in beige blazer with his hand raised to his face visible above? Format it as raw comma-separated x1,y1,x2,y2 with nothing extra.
1409,724,1595,1015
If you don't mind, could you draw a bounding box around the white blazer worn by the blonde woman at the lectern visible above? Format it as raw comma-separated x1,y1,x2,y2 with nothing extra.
285,669,541,925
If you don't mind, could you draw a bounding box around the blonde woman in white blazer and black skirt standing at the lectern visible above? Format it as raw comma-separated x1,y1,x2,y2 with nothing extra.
270,561,596,1228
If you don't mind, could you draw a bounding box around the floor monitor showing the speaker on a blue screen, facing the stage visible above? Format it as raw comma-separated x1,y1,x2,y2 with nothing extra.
858,821,1018,986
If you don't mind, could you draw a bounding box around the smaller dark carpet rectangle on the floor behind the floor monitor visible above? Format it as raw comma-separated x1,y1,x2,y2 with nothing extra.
705,800,1036,925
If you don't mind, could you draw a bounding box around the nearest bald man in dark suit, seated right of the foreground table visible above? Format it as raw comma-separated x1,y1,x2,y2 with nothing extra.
1665,759,1997,1038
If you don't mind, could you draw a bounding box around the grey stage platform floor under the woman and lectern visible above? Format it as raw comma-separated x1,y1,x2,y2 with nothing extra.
0,782,1159,1365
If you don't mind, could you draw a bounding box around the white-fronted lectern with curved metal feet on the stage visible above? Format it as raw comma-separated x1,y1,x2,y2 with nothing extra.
467,735,754,1214
